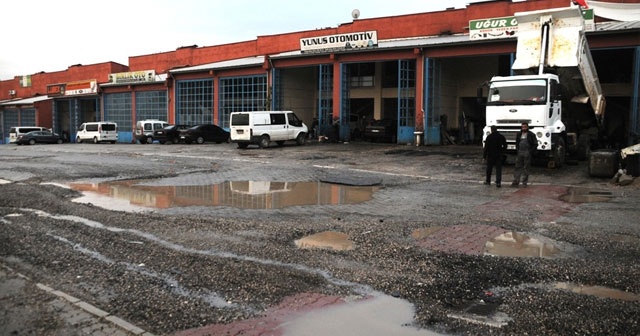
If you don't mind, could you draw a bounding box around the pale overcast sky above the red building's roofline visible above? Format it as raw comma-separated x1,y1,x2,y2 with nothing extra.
0,0,490,80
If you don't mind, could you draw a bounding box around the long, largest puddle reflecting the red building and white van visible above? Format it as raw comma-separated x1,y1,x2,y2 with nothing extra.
70,180,379,211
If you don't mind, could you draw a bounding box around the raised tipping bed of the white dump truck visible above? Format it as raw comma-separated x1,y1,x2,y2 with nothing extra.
512,7,605,119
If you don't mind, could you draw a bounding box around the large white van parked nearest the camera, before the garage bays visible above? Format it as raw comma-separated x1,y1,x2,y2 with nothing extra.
230,111,309,148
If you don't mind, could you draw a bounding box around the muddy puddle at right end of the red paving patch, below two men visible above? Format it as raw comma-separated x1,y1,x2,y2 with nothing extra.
484,232,560,257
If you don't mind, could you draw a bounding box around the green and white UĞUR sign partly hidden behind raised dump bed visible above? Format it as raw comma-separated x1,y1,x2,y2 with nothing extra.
469,9,595,40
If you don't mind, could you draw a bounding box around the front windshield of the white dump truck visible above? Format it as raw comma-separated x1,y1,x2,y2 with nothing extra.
487,79,547,105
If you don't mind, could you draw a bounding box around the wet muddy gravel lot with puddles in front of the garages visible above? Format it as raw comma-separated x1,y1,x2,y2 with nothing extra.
0,143,640,335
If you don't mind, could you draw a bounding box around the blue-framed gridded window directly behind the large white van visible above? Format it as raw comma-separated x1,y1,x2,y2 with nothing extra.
218,75,269,128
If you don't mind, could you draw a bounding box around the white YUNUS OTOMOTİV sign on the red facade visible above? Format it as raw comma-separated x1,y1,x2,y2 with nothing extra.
300,30,378,53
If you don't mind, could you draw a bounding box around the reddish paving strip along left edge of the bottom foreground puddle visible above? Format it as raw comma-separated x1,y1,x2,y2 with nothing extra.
175,293,345,336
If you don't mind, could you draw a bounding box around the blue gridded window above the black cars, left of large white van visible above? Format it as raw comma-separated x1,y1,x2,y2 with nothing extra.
176,79,213,125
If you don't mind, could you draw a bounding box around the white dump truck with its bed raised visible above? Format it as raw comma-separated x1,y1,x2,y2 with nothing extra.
483,7,605,168
